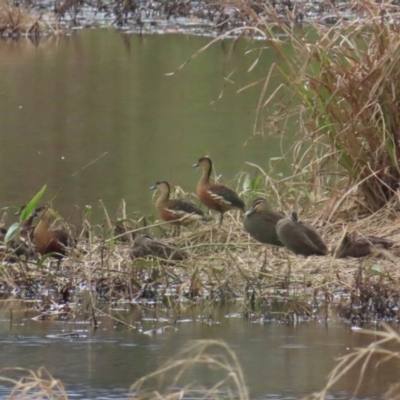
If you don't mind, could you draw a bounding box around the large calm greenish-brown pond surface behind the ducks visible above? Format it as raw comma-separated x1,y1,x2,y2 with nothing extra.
0,30,290,223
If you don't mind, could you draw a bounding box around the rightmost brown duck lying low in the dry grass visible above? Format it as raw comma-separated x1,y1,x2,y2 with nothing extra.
332,232,394,258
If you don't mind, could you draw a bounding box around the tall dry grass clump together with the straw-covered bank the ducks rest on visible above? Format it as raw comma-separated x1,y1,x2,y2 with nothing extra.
0,2,400,320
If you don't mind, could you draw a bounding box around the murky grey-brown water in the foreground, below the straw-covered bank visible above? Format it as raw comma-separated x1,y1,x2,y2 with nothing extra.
0,306,397,399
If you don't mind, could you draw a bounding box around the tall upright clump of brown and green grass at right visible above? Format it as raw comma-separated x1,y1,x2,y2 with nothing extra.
181,0,400,214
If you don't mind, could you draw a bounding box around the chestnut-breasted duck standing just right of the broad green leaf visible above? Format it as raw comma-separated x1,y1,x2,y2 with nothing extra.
32,205,72,265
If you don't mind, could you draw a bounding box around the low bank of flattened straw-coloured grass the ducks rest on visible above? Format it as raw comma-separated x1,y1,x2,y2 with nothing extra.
0,191,400,325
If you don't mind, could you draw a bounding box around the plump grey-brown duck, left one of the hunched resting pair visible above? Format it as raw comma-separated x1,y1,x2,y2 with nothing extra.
243,198,285,246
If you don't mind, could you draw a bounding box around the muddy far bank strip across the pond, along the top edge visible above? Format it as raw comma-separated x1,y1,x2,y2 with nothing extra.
0,0,382,37
